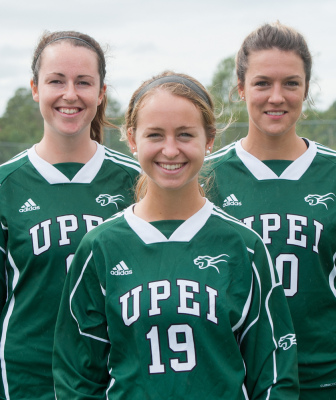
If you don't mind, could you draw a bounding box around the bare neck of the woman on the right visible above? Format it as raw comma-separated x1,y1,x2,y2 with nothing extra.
242,134,307,161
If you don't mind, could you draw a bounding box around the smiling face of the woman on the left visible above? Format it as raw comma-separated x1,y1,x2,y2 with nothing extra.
31,41,106,141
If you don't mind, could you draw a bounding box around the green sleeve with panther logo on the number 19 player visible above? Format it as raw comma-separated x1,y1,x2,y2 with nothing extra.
240,240,299,400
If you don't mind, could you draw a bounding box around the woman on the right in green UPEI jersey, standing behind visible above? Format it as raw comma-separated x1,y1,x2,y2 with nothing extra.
206,23,336,400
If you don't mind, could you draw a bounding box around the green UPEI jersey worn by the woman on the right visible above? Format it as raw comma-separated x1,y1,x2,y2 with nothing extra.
205,141,336,400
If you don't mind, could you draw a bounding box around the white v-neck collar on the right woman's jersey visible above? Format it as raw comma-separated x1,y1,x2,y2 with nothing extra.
235,139,317,181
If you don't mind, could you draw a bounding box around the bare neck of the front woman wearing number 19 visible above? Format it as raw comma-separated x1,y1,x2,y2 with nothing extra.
134,182,205,222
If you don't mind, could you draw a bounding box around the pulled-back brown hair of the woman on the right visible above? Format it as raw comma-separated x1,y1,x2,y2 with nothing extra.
236,21,312,96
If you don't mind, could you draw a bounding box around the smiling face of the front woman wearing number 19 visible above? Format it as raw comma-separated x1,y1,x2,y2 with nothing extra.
128,89,213,197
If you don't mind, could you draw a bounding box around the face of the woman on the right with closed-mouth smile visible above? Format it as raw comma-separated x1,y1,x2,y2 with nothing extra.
238,48,308,141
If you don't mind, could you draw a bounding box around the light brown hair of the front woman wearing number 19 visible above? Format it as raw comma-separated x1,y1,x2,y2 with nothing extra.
122,71,216,201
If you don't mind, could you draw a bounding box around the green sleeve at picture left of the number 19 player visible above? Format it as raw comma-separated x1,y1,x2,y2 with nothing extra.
53,239,110,400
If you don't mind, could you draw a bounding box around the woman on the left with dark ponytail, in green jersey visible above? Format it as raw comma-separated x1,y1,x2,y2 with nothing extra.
0,32,140,400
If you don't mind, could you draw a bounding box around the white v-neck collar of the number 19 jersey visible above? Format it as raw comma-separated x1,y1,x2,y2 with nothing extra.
124,199,213,244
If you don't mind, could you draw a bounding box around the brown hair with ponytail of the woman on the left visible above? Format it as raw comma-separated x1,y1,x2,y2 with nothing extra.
31,31,116,143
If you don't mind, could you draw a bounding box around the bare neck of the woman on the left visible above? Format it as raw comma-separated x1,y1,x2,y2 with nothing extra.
35,135,97,164
